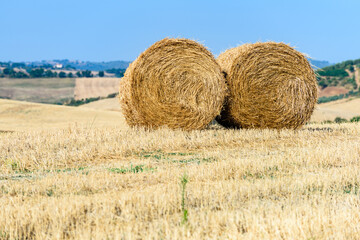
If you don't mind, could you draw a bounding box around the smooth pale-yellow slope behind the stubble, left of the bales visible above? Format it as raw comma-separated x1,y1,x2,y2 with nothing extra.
0,99,126,131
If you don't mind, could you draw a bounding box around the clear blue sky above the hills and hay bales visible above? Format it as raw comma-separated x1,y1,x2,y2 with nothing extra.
0,0,360,63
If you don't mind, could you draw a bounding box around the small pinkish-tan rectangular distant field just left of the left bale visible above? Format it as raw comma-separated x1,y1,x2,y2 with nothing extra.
74,77,120,100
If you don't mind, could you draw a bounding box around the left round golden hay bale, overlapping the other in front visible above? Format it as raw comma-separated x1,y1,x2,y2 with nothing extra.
119,38,226,130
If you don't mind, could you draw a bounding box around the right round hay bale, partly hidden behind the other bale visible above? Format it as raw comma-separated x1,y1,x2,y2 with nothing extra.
216,42,318,129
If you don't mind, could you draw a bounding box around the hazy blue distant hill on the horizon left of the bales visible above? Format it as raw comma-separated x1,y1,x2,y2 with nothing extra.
25,59,130,71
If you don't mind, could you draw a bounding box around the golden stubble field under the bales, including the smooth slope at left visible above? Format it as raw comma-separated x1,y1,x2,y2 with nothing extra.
0,100,360,239
